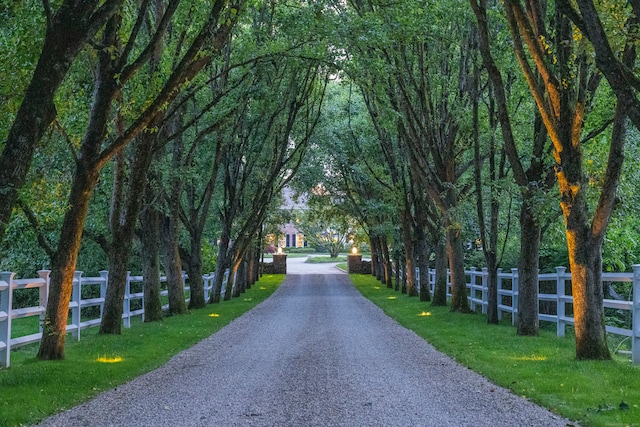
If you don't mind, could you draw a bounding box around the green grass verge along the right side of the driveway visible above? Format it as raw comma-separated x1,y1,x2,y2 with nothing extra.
351,274,640,427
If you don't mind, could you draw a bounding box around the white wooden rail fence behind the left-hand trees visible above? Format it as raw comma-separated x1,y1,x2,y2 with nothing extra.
0,270,229,367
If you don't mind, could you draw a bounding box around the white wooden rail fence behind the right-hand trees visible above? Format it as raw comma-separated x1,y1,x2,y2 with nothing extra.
417,265,640,364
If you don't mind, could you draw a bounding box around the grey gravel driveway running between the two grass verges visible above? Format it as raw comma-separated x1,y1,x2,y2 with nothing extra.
35,262,573,427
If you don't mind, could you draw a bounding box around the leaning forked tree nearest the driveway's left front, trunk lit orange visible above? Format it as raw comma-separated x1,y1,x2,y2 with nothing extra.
38,0,242,360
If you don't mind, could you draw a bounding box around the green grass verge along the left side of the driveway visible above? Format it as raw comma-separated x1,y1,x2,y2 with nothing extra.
0,274,285,427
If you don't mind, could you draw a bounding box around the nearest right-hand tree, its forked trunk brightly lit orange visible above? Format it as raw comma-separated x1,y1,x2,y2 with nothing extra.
504,0,627,359
